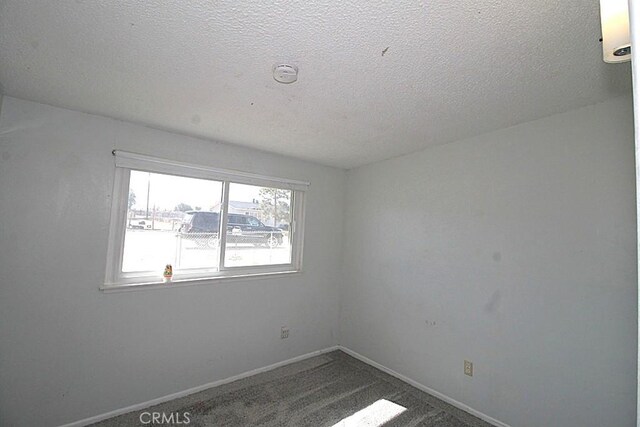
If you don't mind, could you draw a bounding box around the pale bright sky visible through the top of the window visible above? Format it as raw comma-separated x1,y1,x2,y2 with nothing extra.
129,170,288,210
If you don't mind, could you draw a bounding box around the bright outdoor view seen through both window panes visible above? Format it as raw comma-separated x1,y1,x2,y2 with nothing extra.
116,170,296,288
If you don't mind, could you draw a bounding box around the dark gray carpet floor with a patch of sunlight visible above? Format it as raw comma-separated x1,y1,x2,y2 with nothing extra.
94,351,490,427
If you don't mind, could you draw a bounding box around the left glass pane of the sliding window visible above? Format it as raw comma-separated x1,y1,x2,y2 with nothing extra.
122,170,222,275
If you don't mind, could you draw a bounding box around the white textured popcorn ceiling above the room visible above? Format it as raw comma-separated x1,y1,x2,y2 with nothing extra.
0,0,630,168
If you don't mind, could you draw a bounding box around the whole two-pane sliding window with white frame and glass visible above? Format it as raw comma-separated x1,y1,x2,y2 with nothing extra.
103,151,308,289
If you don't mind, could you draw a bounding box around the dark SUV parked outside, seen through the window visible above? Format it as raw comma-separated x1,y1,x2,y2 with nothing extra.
178,211,283,248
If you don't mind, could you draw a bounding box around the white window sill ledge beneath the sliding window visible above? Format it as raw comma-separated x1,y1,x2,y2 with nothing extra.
100,270,302,293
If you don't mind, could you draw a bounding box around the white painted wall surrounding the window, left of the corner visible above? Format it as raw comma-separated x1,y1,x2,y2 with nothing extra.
0,97,345,425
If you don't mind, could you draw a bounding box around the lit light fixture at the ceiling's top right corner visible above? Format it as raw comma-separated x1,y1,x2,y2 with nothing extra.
600,0,631,63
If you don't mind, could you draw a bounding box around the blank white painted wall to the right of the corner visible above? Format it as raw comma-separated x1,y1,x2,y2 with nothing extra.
340,97,637,427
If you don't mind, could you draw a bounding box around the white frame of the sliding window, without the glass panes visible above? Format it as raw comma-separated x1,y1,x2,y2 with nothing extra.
100,150,309,290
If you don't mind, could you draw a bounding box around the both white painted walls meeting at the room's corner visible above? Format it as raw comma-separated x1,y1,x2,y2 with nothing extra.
0,97,637,427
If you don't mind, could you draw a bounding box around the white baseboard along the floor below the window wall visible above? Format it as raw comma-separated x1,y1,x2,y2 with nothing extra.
60,345,340,427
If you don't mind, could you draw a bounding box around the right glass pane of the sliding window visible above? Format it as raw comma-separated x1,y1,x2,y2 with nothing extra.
224,183,292,267
